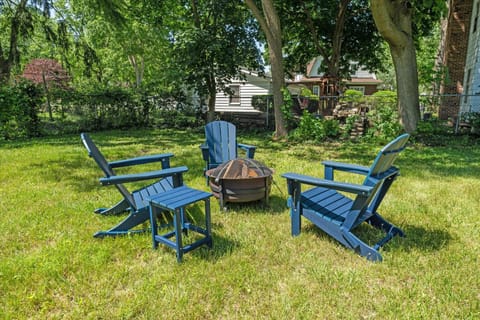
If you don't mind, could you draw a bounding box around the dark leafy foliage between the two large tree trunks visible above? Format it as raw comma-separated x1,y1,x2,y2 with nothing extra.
281,0,383,78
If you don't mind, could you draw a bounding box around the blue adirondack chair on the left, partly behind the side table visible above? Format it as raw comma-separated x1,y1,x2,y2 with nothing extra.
80,133,188,237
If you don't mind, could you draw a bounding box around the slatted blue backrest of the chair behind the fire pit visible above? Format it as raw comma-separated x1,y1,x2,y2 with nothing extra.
205,121,237,165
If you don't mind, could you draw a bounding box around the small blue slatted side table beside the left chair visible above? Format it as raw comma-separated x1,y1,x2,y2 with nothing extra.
150,186,213,262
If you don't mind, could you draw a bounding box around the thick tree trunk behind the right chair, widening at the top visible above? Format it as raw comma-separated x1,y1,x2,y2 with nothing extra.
370,0,420,133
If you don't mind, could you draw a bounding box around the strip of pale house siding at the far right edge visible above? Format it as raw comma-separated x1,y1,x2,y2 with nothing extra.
460,0,480,112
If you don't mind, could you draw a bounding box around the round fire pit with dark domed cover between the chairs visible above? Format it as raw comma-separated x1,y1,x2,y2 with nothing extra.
205,158,273,208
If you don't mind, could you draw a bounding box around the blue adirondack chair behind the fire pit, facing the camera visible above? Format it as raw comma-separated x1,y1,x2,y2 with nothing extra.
200,121,256,171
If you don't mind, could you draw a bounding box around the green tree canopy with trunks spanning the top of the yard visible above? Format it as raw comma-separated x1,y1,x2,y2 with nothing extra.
0,0,446,136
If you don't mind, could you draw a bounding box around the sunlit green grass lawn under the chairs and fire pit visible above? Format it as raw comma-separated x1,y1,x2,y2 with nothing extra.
0,130,480,319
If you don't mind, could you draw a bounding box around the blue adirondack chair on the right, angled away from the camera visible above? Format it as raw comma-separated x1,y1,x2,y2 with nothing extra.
282,134,409,261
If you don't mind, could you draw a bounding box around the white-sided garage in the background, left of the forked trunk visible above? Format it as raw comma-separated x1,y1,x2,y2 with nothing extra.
215,74,271,113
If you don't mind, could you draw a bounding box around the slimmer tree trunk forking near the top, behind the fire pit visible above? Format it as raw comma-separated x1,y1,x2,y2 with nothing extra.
245,0,288,138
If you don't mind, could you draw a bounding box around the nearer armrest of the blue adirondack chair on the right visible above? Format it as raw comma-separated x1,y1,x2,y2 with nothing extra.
282,172,373,196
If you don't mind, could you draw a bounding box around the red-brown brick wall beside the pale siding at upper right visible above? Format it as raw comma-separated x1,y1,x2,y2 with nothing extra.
439,0,473,120
